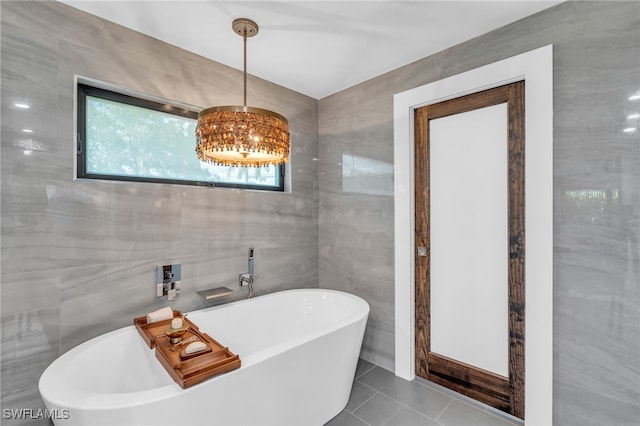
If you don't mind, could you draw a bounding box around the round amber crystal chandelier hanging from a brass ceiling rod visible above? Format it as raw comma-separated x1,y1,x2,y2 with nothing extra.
196,18,290,167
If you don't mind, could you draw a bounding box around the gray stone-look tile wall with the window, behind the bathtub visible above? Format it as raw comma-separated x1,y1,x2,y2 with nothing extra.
1,1,318,420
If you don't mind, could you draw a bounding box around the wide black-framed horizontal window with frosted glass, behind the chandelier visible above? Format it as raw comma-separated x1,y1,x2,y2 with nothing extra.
77,83,284,191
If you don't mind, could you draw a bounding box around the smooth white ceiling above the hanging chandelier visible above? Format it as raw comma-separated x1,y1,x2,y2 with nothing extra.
59,0,561,99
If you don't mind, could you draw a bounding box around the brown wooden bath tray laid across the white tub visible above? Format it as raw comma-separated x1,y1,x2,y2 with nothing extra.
133,310,241,388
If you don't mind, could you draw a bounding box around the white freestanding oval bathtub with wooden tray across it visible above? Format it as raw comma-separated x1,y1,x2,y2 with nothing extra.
39,289,369,426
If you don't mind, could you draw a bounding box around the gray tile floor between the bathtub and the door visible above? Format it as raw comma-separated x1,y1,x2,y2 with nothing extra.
325,359,523,426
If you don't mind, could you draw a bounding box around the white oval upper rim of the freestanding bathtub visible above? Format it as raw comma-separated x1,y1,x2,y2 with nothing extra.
38,288,370,410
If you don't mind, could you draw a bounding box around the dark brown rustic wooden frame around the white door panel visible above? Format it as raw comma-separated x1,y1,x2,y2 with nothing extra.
414,81,525,418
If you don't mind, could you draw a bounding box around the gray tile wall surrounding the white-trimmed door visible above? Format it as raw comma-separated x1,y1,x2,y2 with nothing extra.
319,1,640,425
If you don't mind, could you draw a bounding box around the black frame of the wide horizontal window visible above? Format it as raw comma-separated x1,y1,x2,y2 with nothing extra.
75,81,285,192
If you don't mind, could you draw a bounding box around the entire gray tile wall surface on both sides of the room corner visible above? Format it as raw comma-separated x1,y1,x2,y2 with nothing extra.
0,1,640,424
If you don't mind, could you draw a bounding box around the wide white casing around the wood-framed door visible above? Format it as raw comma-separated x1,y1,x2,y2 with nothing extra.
388,45,553,425
